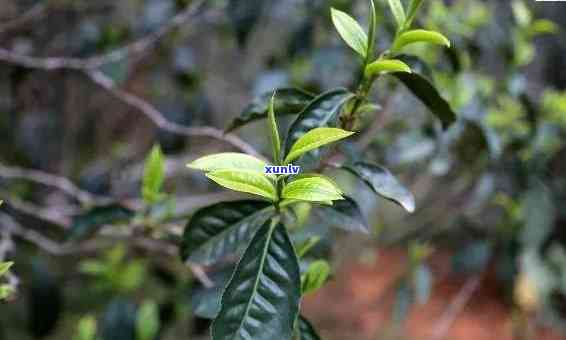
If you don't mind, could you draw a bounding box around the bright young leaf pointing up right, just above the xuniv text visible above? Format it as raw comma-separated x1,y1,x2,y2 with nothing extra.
284,127,355,164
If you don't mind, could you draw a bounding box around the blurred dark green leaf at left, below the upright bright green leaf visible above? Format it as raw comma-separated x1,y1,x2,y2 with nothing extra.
68,203,134,240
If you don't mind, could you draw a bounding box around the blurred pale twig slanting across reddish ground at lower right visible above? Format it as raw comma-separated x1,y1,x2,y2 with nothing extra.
429,275,481,340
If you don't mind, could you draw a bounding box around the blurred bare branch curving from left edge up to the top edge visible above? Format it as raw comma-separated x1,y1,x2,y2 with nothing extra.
0,0,206,71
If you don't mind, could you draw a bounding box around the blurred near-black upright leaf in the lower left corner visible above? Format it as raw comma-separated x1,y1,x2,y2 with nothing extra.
28,262,63,338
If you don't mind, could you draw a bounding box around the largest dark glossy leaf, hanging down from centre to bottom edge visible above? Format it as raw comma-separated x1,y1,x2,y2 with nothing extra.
212,221,301,340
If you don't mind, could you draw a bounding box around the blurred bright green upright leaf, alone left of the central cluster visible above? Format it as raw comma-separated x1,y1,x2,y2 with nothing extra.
142,144,164,204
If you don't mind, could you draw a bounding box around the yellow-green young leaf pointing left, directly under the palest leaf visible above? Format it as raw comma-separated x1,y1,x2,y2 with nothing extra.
206,170,277,201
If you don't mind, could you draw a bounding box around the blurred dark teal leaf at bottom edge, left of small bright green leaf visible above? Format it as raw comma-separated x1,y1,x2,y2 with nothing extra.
100,299,136,340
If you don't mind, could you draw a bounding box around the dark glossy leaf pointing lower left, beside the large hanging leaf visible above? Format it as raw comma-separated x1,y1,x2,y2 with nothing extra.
181,200,273,265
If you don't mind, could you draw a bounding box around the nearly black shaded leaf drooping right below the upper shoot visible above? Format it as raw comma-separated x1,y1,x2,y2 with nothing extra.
393,72,456,129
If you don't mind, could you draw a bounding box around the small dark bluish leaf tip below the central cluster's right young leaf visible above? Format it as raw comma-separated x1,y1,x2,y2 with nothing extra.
319,196,370,233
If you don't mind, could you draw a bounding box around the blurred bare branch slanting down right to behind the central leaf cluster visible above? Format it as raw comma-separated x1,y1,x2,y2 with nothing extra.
85,71,262,157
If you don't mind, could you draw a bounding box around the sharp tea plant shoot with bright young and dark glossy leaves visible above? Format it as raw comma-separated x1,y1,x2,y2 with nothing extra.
181,0,456,340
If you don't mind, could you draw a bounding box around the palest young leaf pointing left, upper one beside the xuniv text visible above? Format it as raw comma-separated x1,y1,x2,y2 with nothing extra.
187,152,267,178
